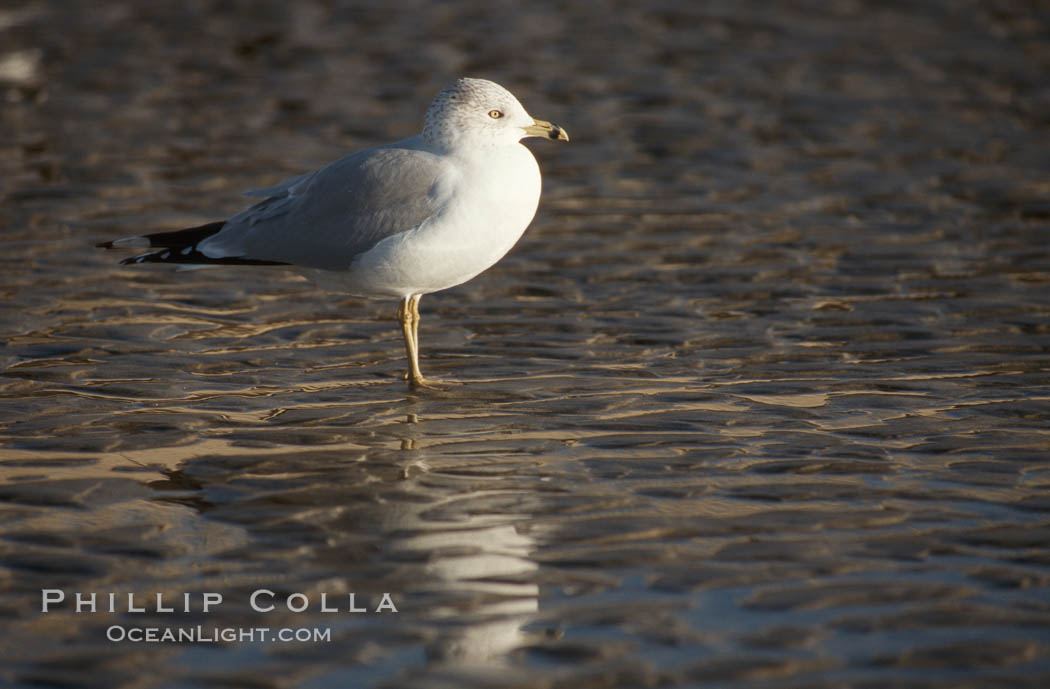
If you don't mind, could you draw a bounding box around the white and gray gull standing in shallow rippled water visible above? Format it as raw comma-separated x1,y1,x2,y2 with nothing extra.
98,78,569,388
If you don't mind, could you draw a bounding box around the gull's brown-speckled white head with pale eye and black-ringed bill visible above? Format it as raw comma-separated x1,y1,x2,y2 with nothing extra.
423,79,569,148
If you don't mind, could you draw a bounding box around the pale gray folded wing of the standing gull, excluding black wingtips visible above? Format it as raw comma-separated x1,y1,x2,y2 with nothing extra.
198,138,446,270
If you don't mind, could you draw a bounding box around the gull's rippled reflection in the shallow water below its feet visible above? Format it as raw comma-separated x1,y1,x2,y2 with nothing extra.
137,398,542,676
